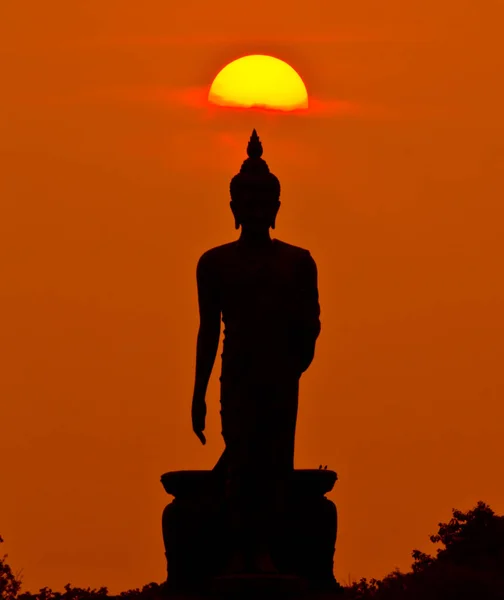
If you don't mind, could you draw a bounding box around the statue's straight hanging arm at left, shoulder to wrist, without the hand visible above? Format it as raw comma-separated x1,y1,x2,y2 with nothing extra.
193,253,221,402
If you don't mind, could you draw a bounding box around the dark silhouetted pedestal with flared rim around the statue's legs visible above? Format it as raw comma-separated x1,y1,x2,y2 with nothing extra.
161,469,340,599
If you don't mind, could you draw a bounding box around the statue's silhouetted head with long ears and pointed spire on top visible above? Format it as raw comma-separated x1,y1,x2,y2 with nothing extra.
230,129,280,232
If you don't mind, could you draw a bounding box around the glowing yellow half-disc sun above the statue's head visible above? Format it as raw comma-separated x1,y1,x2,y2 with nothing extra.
208,54,308,111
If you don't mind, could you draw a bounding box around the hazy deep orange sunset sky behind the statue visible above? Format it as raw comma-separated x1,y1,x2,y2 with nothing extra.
0,0,504,592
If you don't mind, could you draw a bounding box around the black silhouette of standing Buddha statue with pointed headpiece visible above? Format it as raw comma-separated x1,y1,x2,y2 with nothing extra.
192,129,320,572
